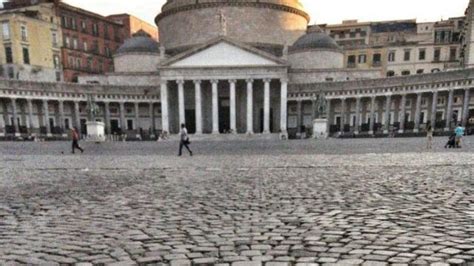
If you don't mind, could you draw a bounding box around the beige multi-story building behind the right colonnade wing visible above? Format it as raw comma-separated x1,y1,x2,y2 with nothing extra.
320,17,464,77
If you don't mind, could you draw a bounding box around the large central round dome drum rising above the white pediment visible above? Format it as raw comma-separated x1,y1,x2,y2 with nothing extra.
155,0,309,53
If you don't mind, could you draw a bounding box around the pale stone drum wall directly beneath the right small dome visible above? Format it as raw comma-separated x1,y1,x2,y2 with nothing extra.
288,50,344,69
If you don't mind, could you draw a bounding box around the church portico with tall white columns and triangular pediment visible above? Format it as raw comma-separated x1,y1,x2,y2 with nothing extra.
159,37,288,135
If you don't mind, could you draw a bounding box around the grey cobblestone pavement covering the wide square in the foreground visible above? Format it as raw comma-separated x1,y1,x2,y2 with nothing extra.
0,138,474,266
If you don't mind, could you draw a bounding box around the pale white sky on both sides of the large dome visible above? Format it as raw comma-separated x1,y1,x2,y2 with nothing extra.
29,0,469,24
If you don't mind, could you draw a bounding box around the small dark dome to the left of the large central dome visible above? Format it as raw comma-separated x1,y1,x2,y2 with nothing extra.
115,30,160,54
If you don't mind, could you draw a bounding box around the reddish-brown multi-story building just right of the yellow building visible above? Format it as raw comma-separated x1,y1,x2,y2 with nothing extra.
4,0,128,82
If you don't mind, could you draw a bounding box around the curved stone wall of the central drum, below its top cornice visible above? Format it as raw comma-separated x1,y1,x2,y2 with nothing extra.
158,6,308,49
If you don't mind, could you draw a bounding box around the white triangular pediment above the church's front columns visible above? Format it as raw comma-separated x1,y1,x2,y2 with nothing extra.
162,39,284,68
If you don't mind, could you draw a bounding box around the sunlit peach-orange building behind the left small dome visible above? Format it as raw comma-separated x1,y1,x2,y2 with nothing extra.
107,14,159,41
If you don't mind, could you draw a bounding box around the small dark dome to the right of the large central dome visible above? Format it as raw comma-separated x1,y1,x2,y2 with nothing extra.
289,26,341,52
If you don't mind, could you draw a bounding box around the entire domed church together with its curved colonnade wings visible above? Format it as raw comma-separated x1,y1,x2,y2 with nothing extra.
0,0,474,139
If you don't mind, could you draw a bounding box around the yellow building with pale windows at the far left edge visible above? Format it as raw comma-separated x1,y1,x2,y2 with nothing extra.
0,4,62,82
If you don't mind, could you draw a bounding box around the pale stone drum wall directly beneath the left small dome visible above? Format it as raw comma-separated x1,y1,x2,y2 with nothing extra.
114,53,160,72
